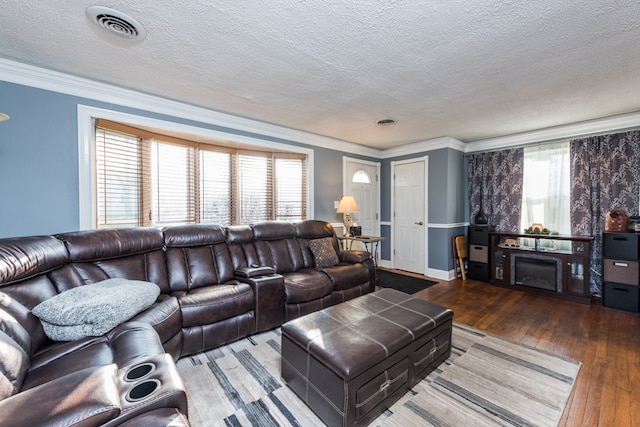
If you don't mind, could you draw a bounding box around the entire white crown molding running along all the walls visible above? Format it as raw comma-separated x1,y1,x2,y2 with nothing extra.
0,58,640,159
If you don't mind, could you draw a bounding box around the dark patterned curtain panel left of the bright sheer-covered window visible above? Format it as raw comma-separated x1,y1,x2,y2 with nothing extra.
468,148,524,232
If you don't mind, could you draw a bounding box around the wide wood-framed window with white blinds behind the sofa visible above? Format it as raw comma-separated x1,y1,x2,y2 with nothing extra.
95,119,307,227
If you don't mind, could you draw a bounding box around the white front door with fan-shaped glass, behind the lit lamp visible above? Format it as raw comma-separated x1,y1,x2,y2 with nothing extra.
344,158,380,241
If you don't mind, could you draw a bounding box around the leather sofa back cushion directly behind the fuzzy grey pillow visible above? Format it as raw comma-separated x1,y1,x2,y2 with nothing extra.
49,227,170,293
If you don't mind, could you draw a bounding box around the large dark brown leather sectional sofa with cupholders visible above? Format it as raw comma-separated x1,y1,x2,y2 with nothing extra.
0,220,375,426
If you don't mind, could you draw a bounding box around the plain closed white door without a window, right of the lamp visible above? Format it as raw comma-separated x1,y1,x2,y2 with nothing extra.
392,160,427,274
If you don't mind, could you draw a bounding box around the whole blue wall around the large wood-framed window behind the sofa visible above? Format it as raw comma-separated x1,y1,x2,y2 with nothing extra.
0,81,377,237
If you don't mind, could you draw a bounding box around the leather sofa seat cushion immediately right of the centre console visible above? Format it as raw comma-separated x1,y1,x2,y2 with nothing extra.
283,268,333,304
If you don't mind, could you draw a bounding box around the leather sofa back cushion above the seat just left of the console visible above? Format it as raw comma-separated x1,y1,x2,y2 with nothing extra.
163,224,234,292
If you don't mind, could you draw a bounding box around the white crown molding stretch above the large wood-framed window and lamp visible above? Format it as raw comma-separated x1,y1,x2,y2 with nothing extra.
0,58,381,158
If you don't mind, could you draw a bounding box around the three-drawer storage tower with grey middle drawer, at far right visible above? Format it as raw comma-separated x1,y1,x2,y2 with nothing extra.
602,233,640,313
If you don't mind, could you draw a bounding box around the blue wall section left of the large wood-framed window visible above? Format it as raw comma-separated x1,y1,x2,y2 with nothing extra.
0,82,78,236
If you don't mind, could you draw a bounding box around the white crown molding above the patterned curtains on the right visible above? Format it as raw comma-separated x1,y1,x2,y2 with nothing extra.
466,112,640,153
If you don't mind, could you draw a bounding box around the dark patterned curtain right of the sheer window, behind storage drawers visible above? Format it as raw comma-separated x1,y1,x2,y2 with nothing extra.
571,131,640,296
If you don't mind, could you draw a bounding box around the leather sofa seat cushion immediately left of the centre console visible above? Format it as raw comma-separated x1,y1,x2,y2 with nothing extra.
178,281,255,328
